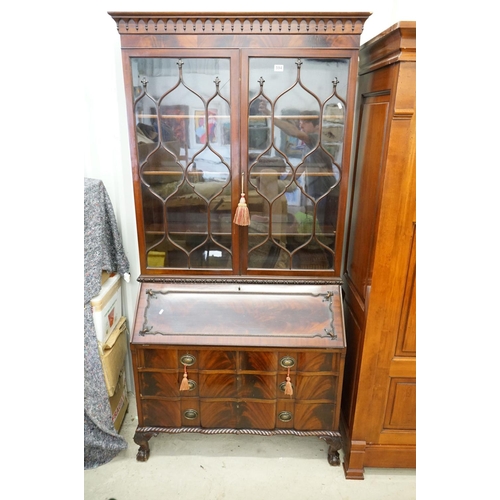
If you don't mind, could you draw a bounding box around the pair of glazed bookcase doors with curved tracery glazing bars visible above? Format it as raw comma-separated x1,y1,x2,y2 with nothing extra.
124,49,352,276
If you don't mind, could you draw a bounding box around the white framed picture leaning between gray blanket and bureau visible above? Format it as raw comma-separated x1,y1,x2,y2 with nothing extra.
90,274,122,342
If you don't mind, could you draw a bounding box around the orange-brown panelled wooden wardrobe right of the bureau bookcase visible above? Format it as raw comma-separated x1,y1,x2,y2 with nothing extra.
341,22,416,479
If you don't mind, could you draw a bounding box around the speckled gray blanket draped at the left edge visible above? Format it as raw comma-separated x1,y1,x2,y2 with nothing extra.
83,178,129,469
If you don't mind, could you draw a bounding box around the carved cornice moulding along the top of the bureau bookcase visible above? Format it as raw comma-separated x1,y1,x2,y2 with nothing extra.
108,12,371,35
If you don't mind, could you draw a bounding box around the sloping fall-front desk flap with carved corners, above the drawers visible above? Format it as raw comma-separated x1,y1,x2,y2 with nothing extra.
132,283,345,349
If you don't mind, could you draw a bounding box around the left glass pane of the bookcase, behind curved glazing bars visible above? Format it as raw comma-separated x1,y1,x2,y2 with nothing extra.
132,58,232,269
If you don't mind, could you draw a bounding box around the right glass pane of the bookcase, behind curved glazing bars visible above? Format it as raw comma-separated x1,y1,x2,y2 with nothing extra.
248,58,349,270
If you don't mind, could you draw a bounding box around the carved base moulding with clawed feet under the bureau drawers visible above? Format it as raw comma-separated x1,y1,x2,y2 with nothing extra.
134,427,342,466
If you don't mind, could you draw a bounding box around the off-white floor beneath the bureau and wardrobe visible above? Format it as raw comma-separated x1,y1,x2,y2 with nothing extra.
84,395,416,500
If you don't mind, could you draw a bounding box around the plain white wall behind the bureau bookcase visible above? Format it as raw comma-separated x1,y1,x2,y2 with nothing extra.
85,0,417,328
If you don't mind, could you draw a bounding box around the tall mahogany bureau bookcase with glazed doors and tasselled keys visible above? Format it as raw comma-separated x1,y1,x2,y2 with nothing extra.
109,12,369,465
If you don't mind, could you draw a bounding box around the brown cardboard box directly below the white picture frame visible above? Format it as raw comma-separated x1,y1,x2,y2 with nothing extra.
99,316,129,396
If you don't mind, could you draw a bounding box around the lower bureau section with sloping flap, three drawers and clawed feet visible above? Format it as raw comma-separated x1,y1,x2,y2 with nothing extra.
131,283,346,465
